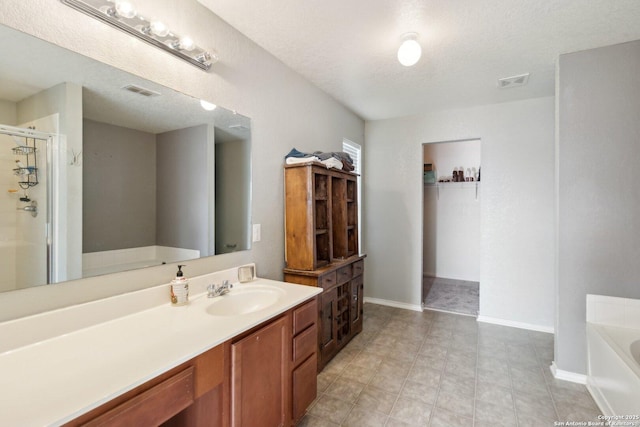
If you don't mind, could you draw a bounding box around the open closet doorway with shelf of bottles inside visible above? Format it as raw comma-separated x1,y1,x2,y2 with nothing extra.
422,139,482,316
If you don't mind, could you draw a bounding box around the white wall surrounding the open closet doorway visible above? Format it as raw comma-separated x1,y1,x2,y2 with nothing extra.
364,97,555,329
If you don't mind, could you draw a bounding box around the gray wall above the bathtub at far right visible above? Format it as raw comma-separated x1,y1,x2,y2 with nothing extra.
555,41,640,374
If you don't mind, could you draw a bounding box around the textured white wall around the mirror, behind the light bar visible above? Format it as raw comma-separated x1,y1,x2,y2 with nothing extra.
0,0,364,320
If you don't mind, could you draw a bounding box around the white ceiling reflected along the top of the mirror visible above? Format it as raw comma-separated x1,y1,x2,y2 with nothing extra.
0,25,250,142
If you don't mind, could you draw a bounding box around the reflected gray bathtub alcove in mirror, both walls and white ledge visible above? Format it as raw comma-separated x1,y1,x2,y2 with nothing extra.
83,119,215,277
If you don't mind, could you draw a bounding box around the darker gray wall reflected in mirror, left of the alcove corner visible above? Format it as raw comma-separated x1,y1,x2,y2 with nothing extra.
82,119,156,253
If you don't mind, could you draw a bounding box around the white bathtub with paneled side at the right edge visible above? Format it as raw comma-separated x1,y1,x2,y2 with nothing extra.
587,297,640,416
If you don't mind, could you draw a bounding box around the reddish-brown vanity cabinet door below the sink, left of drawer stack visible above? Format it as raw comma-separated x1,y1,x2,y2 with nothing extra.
231,317,290,427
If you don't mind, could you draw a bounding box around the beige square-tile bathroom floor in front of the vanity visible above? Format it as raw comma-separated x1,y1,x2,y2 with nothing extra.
300,304,599,427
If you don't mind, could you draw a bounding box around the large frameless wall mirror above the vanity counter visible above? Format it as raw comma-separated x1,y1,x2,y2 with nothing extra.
0,26,251,291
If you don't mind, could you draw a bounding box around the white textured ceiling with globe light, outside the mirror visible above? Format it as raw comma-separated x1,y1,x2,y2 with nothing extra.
198,0,640,120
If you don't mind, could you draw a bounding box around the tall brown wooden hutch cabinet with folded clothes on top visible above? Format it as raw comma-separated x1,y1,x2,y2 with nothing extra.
284,163,364,371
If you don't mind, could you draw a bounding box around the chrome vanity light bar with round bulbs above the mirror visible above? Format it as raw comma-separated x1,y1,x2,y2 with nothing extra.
60,0,218,71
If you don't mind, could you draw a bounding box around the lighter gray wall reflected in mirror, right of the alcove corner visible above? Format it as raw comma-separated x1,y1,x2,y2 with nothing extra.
157,125,214,256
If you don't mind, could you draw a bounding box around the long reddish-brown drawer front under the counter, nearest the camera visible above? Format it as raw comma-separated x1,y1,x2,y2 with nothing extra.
84,366,194,426
